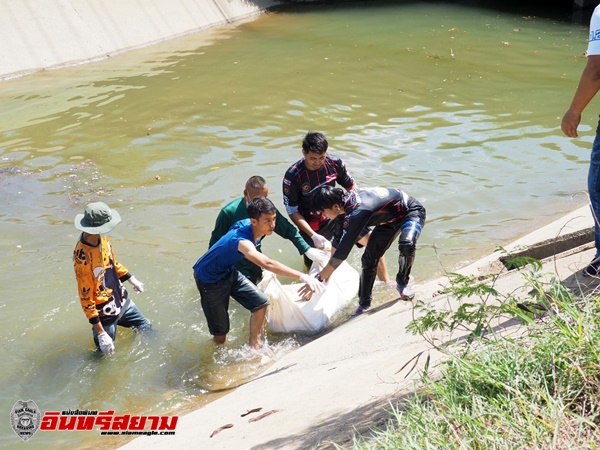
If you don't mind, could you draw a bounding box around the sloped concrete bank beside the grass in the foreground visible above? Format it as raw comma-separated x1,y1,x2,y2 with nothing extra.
119,207,599,450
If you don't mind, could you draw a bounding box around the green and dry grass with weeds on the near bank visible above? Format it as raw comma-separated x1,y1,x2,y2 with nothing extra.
354,253,600,450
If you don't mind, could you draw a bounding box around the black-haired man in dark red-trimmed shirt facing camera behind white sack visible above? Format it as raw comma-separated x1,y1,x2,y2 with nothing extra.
283,131,389,283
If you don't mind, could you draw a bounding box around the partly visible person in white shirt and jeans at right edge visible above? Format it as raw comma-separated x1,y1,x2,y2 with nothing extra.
561,5,600,278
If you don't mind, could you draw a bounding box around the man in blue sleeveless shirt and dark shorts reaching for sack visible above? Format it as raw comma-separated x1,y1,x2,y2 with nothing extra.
194,197,324,349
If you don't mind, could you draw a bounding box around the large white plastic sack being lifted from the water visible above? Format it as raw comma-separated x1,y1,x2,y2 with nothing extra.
258,262,359,333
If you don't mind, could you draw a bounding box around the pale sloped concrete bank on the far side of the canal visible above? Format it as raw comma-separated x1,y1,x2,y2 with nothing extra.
0,0,276,80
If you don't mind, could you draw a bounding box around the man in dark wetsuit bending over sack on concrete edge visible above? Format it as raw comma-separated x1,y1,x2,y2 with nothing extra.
312,185,426,315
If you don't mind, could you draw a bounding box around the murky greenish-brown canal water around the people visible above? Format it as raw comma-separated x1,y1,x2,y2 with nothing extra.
0,2,599,448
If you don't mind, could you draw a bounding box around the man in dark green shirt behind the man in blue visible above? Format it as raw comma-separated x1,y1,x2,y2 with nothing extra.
208,175,320,284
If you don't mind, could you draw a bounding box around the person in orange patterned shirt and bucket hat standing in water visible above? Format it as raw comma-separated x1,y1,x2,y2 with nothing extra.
73,202,152,356
